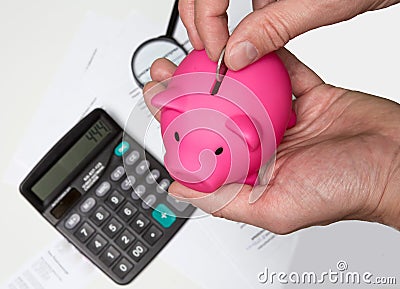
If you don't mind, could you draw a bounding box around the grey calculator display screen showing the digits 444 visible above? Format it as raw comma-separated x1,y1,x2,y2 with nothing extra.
32,119,112,201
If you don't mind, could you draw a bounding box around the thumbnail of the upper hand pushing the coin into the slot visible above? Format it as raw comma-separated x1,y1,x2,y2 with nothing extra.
228,41,258,70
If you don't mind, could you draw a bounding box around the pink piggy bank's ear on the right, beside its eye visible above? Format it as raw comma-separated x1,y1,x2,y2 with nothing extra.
225,115,260,151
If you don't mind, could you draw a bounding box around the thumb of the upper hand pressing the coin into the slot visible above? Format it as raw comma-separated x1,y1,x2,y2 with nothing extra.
225,0,356,70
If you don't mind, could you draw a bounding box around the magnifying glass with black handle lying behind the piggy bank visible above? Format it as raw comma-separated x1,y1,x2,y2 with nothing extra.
131,0,187,88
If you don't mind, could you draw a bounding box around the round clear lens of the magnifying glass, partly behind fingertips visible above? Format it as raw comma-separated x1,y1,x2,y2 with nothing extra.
132,38,187,87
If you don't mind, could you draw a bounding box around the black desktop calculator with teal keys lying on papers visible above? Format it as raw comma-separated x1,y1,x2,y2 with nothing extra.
20,109,195,285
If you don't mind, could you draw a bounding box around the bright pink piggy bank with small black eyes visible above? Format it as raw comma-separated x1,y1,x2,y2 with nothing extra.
152,50,296,193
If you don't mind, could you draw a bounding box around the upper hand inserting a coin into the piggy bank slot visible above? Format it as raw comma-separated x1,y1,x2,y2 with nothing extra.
179,0,400,70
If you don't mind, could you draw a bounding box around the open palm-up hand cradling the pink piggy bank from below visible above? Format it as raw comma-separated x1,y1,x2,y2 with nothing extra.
144,49,400,234
